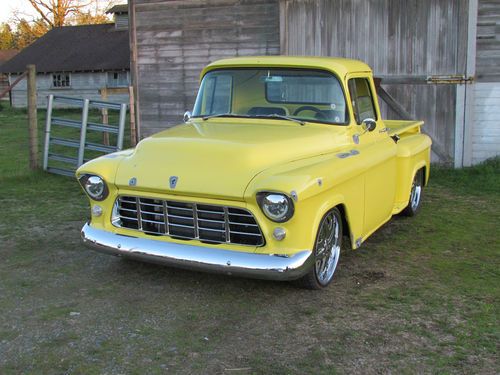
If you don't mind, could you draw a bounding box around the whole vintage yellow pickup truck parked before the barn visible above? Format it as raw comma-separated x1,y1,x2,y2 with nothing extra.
76,56,431,289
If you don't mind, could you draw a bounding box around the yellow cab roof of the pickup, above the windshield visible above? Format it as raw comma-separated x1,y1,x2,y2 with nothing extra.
200,56,372,78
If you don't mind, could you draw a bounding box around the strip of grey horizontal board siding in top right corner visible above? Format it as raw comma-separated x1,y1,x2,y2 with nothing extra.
476,0,500,82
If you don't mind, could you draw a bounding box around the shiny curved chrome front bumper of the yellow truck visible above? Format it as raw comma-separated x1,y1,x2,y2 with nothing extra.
82,224,314,281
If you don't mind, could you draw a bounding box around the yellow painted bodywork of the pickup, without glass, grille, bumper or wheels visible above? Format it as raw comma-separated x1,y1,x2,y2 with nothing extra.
77,56,431,254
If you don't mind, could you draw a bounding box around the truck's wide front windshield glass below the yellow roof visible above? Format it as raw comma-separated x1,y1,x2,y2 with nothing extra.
193,68,347,124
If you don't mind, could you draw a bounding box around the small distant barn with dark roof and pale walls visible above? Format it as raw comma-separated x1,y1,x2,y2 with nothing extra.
0,5,130,108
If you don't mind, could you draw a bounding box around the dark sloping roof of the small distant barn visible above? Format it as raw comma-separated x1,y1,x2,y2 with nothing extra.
0,24,130,73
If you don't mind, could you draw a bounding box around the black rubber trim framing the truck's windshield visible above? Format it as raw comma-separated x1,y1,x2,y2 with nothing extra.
192,65,351,126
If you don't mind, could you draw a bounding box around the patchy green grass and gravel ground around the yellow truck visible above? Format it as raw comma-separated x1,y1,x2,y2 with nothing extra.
0,109,500,374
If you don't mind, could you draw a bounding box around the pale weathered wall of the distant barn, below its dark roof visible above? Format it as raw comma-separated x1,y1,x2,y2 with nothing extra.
10,72,129,108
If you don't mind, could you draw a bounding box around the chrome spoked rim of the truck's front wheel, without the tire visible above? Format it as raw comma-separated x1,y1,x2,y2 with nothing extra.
314,210,342,286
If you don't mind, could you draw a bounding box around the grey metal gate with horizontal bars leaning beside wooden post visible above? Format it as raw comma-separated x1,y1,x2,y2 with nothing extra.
43,95,127,176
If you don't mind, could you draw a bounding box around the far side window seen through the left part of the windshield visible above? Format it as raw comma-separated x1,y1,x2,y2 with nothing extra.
203,74,233,115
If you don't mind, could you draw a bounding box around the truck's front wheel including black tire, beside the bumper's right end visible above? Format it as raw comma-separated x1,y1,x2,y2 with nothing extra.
298,207,342,289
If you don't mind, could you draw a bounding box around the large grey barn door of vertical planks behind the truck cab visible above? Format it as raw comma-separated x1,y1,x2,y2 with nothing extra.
281,0,468,163
